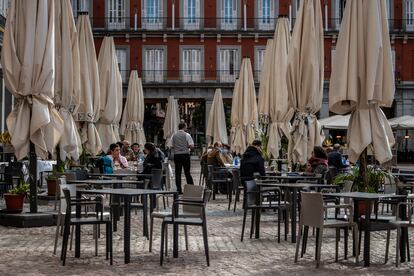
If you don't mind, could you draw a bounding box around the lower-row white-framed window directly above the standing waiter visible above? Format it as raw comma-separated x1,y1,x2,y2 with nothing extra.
181,48,202,82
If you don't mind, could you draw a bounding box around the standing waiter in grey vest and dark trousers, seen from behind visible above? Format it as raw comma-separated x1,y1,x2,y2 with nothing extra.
172,123,194,194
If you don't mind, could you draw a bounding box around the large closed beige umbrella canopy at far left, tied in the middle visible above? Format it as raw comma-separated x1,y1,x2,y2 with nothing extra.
1,0,63,159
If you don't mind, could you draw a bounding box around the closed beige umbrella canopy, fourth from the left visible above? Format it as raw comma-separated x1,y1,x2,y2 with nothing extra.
96,36,122,150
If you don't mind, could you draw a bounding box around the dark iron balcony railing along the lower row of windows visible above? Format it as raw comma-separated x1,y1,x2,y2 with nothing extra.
121,70,260,84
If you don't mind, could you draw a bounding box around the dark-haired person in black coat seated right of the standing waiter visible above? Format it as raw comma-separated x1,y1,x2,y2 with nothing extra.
240,140,266,179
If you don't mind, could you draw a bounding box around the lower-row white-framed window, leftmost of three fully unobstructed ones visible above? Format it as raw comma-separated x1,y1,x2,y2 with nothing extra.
144,47,164,82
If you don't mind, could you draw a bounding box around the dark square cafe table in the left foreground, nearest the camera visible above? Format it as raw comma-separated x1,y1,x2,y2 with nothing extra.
75,188,178,264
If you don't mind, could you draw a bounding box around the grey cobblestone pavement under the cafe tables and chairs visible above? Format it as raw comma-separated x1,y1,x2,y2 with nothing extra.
0,162,414,275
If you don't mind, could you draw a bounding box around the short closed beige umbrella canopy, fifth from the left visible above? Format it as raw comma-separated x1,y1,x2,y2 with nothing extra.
121,70,145,146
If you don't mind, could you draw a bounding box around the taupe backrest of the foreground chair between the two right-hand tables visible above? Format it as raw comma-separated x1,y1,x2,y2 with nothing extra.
300,192,324,228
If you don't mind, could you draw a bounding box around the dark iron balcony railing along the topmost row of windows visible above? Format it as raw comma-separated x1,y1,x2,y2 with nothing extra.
86,16,414,33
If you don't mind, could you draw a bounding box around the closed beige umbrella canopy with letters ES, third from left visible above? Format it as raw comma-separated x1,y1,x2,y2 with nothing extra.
76,14,102,155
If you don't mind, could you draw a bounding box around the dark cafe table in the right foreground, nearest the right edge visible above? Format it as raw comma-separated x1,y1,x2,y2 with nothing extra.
326,192,408,266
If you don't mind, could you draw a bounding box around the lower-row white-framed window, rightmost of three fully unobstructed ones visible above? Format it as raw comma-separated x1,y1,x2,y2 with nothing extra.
217,47,240,82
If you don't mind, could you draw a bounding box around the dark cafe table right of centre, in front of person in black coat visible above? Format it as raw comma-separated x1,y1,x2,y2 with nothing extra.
255,181,340,243
